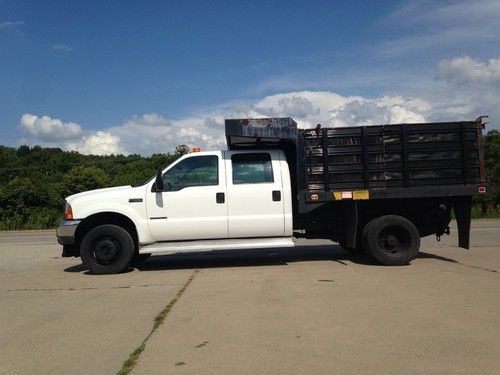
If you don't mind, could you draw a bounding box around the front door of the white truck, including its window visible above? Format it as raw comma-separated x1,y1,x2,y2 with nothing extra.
147,152,228,241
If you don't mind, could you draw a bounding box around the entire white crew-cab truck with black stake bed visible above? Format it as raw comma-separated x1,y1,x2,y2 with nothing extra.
57,118,486,274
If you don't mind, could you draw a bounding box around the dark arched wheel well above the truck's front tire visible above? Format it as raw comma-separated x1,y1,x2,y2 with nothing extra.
75,212,139,251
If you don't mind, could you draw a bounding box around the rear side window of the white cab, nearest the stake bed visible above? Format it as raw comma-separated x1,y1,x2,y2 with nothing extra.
231,153,274,185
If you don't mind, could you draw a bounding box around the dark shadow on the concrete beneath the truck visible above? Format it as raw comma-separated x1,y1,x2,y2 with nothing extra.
64,245,457,273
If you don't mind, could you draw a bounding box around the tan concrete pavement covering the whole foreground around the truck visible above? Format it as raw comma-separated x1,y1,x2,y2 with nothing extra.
0,220,500,374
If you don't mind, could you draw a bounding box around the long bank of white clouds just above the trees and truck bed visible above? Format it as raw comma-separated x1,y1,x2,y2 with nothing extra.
17,56,500,155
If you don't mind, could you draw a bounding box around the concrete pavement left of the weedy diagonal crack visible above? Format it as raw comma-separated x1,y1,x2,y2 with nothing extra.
0,231,192,374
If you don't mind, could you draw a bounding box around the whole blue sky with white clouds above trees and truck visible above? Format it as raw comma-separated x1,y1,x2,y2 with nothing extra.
0,0,500,156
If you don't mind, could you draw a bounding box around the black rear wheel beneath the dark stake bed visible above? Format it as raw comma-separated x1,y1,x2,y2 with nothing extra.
363,215,420,266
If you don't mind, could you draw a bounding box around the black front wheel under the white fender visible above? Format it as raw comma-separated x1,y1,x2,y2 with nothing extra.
80,224,135,275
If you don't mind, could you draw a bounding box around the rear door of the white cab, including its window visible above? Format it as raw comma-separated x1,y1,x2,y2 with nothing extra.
224,151,285,238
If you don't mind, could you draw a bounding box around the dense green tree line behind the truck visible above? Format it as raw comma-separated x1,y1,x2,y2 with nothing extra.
0,130,500,230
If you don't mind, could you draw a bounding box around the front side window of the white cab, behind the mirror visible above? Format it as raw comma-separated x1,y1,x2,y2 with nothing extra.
163,155,219,191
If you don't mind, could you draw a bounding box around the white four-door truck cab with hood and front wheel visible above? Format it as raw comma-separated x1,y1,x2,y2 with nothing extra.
57,149,293,273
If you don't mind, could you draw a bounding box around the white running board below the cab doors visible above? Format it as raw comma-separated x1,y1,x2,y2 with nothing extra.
139,237,294,255
